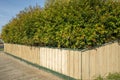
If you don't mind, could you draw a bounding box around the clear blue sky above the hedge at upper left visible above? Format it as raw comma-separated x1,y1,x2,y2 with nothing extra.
0,0,45,33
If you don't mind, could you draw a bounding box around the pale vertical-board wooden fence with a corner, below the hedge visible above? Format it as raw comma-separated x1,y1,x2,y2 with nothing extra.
4,42,120,80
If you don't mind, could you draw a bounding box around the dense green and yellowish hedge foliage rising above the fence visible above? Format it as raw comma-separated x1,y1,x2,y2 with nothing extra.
2,0,120,49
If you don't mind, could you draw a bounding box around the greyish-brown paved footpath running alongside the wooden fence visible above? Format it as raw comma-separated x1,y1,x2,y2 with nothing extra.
0,52,63,80
